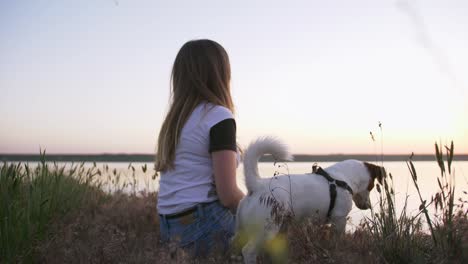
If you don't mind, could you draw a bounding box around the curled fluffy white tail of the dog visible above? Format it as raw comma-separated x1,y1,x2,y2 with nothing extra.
244,137,292,192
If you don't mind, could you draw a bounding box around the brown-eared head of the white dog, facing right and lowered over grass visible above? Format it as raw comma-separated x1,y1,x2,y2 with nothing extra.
353,162,387,210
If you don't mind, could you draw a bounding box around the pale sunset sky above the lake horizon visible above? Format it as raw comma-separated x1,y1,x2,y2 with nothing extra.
0,0,468,154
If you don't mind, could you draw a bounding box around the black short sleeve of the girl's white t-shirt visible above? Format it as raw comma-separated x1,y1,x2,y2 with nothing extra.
208,118,237,153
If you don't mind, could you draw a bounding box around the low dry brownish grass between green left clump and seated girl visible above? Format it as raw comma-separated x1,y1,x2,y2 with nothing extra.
37,192,239,263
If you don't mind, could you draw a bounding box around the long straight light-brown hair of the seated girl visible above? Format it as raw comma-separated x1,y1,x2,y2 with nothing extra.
156,39,234,171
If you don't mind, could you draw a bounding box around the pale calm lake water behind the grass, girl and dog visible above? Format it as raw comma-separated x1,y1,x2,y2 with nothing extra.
75,161,468,228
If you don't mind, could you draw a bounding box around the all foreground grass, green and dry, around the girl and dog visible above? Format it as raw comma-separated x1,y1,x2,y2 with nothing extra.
0,145,468,263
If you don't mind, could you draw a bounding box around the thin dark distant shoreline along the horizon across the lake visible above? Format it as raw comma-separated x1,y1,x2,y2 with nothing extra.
0,154,468,162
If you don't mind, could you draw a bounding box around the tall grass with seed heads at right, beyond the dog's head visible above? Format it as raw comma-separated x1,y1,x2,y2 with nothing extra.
363,142,468,263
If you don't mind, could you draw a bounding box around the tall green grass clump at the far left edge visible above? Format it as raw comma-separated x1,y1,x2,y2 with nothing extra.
0,153,104,263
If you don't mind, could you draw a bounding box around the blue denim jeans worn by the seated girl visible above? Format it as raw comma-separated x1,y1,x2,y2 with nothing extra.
159,201,235,256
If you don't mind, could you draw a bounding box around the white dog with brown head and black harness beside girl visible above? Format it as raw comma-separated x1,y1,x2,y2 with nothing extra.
236,138,385,263
